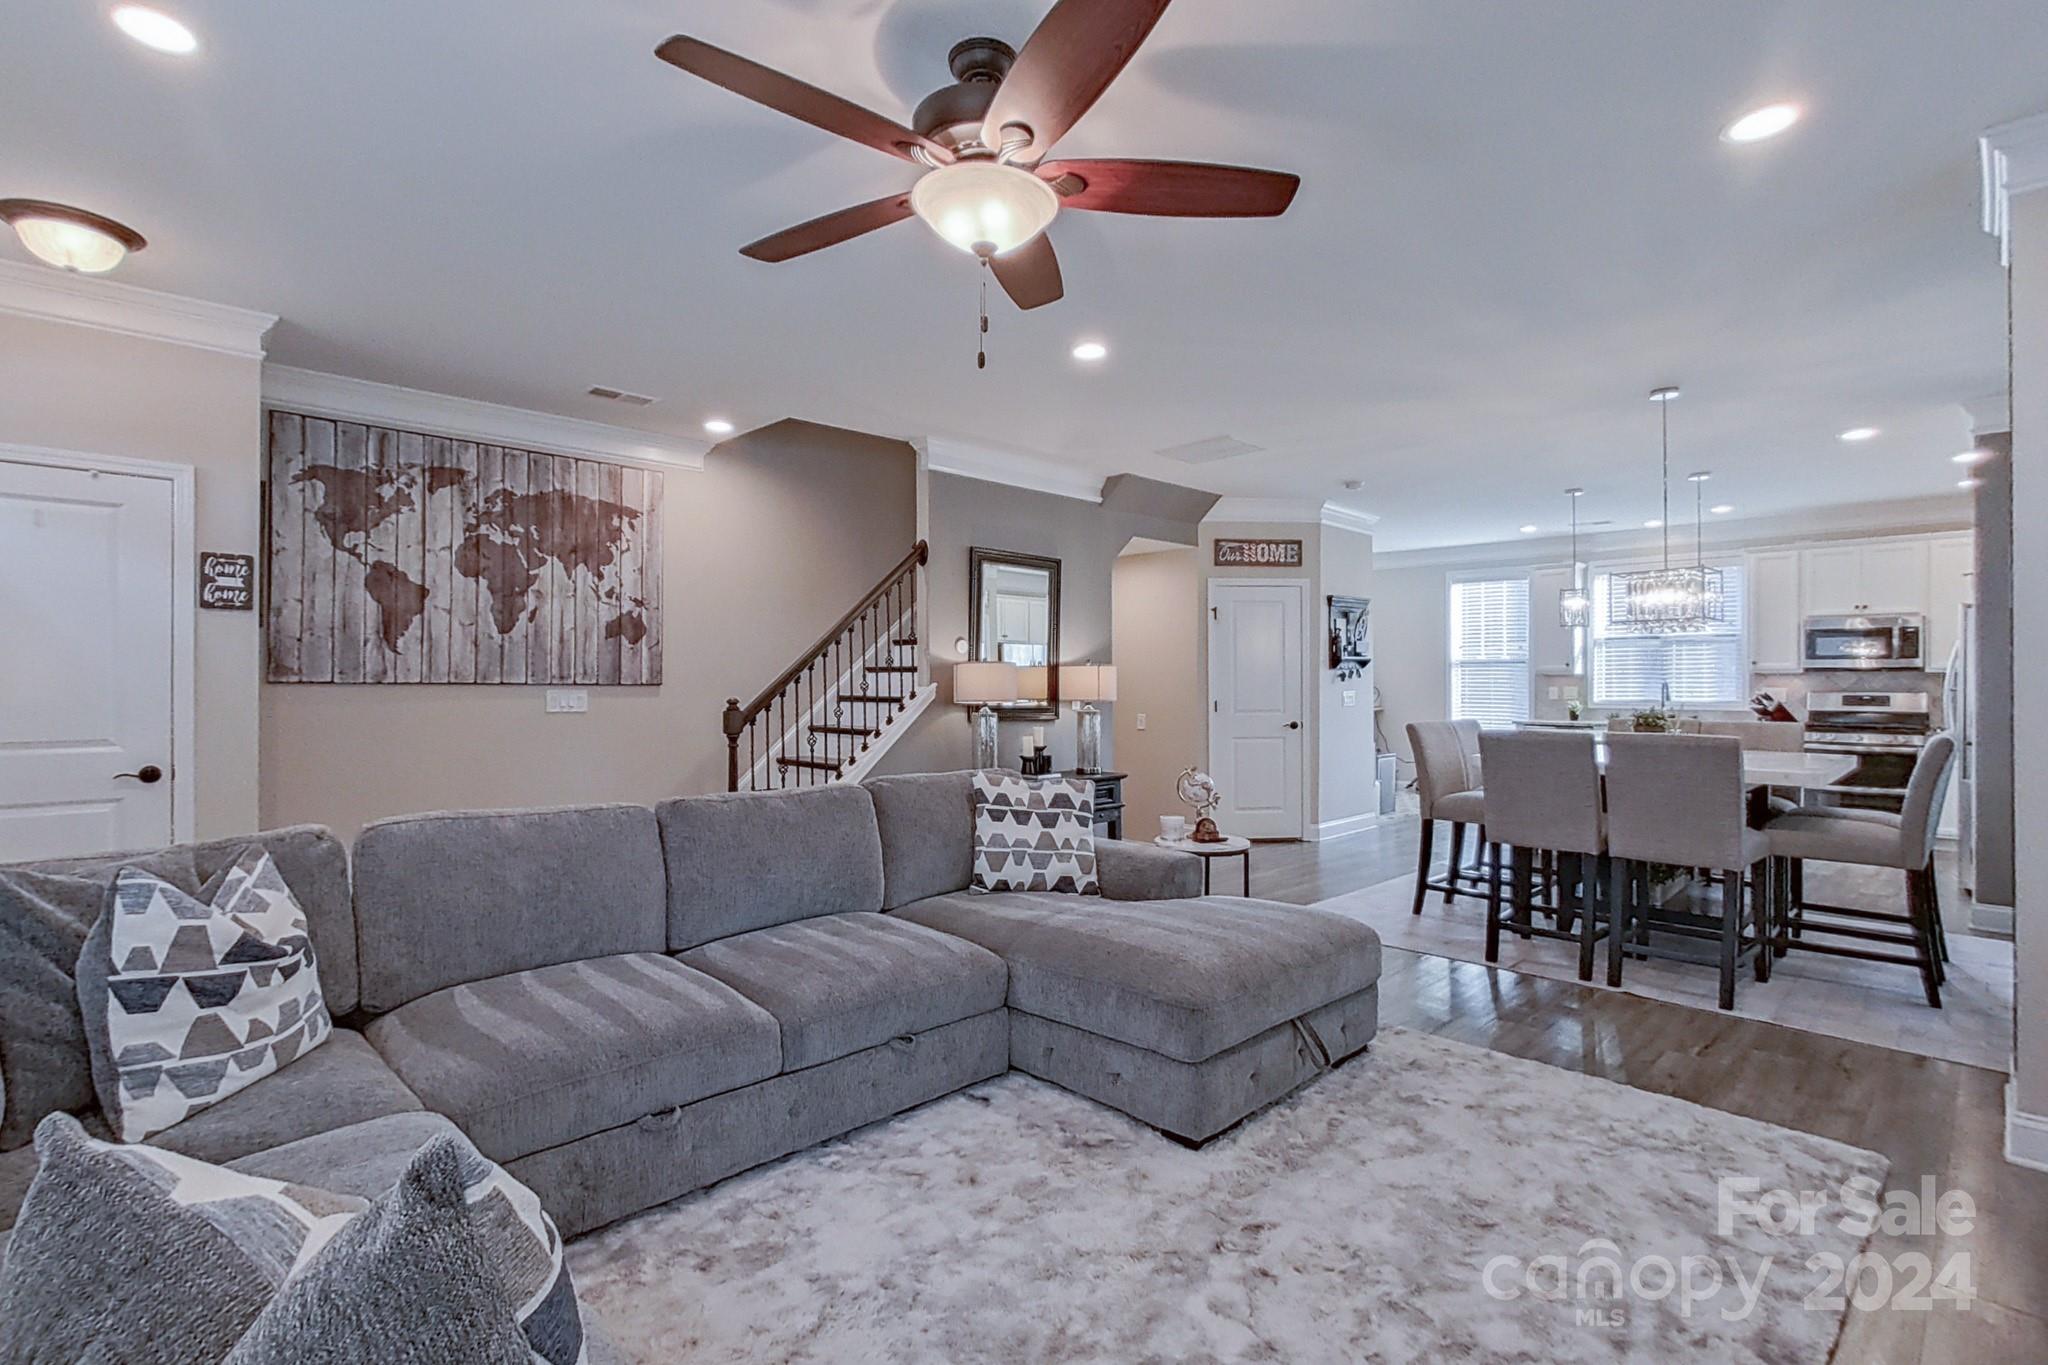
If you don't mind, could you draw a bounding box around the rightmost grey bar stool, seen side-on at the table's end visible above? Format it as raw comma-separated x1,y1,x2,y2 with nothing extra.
1765,733,1956,1009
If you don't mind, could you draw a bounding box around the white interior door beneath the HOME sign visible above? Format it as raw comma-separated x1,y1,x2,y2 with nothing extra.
1208,583,1309,839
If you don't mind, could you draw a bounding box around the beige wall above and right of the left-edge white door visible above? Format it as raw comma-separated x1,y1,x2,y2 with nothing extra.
0,315,262,839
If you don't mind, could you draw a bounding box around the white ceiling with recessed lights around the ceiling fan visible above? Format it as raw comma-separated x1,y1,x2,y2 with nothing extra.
0,0,2048,551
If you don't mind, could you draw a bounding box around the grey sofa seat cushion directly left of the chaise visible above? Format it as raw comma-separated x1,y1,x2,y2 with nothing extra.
680,913,1010,1070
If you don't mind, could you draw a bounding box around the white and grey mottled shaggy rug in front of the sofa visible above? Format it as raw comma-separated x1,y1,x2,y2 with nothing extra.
569,1029,1886,1365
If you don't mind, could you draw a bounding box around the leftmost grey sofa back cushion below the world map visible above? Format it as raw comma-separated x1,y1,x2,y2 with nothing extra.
356,806,664,1015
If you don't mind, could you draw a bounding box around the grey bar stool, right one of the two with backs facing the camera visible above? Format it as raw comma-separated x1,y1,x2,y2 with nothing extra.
1608,735,1772,1009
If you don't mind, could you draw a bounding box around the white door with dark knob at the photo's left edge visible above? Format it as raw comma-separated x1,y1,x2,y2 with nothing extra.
0,458,176,862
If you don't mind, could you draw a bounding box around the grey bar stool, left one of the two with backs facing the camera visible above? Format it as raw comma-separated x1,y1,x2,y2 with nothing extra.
1479,731,1612,980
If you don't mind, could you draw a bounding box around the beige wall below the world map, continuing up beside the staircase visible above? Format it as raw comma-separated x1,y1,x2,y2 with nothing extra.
262,422,918,833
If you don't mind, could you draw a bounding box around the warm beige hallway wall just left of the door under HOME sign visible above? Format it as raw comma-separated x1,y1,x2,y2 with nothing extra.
1110,551,1208,839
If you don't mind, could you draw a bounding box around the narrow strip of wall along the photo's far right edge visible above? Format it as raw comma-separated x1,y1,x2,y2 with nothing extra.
2011,190,2048,1121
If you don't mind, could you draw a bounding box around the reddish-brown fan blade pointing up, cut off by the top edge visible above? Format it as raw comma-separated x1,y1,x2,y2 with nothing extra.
981,0,1169,162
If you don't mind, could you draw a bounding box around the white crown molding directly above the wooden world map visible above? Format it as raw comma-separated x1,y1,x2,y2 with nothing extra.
262,364,711,471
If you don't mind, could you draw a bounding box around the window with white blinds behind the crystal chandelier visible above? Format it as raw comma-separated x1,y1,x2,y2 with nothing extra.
1589,563,1749,708
